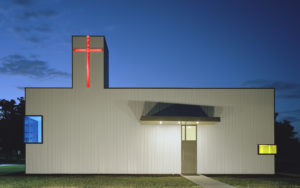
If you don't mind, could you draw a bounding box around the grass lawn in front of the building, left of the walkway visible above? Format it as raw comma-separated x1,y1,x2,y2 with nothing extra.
0,165,200,188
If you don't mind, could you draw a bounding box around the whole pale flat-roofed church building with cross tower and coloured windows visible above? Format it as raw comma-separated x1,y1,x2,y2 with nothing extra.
24,36,277,174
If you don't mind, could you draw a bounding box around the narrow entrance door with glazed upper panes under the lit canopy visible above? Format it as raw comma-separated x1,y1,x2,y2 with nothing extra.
181,124,197,174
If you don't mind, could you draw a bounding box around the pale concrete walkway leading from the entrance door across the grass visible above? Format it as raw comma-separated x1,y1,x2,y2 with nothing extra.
182,175,234,188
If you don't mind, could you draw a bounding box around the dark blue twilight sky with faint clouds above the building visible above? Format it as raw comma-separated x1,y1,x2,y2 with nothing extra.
0,0,300,137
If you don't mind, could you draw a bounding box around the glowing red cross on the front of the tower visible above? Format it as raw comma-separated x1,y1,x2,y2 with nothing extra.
73,36,103,88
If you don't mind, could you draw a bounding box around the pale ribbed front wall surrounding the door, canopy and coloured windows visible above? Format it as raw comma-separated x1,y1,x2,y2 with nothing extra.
26,88,274,174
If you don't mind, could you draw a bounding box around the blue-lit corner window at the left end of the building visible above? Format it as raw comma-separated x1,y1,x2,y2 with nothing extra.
24,116,43,144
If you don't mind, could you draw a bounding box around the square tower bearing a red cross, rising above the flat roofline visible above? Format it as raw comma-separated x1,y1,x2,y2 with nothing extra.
72,36,109,90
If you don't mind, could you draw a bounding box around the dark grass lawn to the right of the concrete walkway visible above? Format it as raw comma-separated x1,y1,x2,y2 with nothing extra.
209,175,300,188
